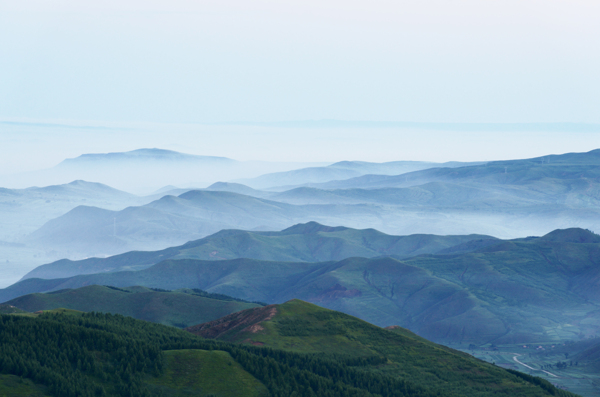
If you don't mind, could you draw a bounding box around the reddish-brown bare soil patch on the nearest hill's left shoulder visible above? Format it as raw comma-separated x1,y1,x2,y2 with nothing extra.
185,305,277,343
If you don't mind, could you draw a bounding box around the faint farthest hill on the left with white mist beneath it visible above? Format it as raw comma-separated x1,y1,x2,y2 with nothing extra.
0,148,328,194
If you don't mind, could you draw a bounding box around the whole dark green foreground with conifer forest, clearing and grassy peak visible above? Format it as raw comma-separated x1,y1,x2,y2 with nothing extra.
0,301,574,397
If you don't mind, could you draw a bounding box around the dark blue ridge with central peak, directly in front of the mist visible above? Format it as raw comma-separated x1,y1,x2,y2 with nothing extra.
23,222,497,279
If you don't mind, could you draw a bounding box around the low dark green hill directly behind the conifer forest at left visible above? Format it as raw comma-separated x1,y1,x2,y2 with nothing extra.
7,285,260,328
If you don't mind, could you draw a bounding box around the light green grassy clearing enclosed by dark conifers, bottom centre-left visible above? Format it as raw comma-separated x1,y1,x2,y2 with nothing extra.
148,350,269,397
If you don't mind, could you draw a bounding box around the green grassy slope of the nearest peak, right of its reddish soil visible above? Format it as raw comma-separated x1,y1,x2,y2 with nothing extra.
189,300,576,395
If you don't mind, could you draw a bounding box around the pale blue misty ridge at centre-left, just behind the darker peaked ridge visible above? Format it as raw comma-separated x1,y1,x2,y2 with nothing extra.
24,190,398,256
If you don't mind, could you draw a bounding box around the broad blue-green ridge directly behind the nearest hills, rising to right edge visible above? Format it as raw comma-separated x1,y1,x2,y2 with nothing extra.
5,229,600,344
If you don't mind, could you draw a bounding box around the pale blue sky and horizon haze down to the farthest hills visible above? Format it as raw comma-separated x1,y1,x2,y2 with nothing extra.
0,0,600,170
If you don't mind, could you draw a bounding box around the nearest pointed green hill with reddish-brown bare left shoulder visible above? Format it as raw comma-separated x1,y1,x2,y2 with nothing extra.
186,300,576,395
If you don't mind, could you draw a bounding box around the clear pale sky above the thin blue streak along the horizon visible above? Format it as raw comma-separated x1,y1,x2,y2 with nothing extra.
0,0,600,123
